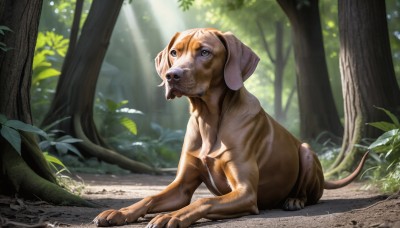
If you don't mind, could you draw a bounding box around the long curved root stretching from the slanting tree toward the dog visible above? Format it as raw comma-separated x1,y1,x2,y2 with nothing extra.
72,114,161,174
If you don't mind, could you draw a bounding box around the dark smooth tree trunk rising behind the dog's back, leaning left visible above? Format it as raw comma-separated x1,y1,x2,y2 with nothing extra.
277,0,343,140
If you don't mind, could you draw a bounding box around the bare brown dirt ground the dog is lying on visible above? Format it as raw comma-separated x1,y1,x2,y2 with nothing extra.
0,174,400,228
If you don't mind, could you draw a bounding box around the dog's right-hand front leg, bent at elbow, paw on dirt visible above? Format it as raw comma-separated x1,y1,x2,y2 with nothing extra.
147,163,258,228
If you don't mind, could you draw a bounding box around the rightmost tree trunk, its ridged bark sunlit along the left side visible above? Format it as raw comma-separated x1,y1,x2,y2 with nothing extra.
326,0,400,176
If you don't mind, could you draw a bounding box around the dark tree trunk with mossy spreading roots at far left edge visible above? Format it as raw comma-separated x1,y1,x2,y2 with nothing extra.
0,0,90,206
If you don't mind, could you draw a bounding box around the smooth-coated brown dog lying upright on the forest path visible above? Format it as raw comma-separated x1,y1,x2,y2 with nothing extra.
94,29,366,228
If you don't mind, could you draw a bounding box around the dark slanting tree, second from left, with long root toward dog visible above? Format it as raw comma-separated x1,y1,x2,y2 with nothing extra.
42,0,155,173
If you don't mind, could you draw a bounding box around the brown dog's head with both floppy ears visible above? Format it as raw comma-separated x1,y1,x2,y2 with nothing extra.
155,29,259,99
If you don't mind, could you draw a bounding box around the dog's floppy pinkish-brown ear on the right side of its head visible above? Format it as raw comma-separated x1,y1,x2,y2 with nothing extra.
220,32,260,90
